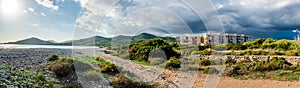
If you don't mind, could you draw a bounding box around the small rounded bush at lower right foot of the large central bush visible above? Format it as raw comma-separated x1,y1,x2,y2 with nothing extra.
166,57,181,68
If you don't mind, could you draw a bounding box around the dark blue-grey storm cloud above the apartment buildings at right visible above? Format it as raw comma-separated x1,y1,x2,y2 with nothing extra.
213,0,300,39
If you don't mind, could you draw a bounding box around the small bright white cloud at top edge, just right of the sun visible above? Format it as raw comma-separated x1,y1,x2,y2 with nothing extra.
35,0,59,10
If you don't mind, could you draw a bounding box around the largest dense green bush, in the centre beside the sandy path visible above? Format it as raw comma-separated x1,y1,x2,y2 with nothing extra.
128,38,180,68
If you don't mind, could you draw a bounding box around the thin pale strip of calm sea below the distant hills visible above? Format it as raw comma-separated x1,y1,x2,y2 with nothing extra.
0,44,98,49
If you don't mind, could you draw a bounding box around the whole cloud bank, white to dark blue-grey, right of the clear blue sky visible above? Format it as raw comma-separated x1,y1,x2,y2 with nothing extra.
78,0,300,39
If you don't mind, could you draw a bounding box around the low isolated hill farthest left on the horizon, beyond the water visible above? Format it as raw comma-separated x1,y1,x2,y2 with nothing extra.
5,37,55,45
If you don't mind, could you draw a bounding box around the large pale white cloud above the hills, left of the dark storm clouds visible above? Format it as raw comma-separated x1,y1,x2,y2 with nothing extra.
76,0,200,35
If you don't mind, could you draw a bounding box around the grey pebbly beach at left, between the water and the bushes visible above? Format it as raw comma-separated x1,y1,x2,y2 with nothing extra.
0,48,86,88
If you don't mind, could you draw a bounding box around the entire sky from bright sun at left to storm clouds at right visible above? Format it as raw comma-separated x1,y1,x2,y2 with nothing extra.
0,0,300,42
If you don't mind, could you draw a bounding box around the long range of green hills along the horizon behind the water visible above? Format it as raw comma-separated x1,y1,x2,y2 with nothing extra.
5,33,176,46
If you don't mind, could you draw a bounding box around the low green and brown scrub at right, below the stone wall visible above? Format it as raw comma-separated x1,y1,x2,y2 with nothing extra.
224,57,300,81
